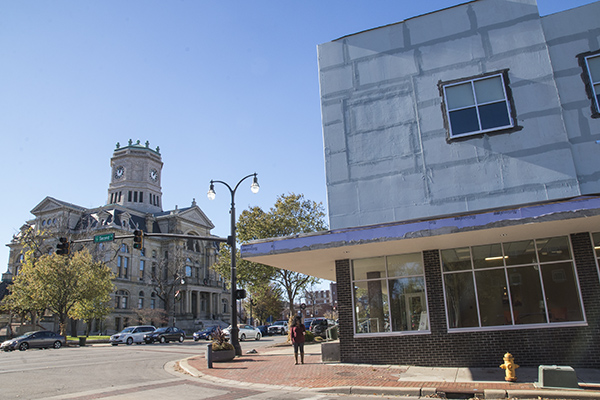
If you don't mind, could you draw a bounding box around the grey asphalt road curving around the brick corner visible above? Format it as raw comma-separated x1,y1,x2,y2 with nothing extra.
0,336,394,400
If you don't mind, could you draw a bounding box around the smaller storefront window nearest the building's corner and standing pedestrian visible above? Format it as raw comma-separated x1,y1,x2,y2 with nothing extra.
352,253,429,334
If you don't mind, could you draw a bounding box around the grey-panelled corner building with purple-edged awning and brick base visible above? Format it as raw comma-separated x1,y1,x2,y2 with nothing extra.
241,0,600,368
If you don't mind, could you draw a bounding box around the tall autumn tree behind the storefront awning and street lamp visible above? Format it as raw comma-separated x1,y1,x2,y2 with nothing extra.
213,193,327,315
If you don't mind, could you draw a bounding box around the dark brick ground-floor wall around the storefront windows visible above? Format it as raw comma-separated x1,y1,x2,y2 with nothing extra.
336,232,600,368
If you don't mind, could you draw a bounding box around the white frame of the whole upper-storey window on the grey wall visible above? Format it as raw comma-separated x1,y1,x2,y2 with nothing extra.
441,72,515,139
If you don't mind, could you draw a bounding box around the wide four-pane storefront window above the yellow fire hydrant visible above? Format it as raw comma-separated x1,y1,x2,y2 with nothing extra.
440,236,584,329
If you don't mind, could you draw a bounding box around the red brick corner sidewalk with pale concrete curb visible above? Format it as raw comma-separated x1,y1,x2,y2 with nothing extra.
180,344,600,399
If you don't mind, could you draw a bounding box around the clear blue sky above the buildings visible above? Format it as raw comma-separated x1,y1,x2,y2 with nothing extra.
0,0,593,288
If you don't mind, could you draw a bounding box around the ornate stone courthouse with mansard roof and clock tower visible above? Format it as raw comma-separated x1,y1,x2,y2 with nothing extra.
2,140,230,334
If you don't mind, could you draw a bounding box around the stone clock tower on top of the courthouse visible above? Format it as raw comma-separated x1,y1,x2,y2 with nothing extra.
107,139,163,213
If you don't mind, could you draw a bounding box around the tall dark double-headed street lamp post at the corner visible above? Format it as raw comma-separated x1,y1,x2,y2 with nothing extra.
208,173,260,356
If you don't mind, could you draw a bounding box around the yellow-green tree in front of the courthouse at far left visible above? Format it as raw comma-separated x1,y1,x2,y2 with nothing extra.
3,250,114,335
